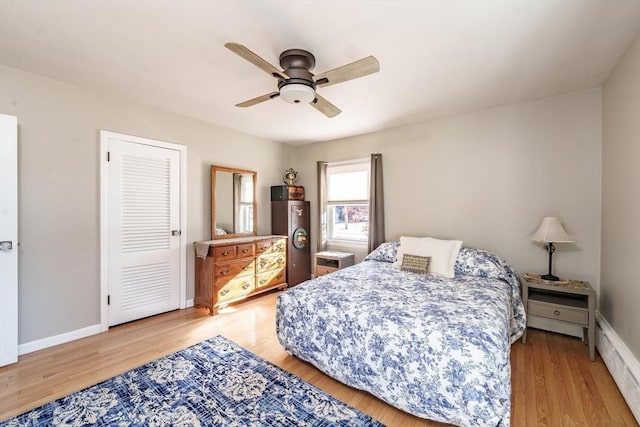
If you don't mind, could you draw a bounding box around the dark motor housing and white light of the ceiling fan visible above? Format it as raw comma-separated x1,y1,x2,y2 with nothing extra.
278,49,316,104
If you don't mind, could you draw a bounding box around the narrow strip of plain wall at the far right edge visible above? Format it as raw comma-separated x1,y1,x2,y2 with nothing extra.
600,28,640,360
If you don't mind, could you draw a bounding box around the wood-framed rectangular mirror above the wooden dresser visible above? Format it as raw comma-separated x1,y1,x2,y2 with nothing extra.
211,165,258,240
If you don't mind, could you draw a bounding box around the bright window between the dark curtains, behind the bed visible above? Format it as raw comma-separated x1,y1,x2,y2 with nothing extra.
326,159,370,243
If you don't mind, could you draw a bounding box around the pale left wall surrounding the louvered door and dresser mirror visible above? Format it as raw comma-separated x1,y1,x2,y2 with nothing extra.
0,66,291,344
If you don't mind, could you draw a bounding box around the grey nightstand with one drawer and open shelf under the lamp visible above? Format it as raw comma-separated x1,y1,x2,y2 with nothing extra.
521,274,596,361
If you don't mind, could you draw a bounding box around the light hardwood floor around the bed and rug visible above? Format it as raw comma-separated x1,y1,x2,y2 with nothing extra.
0,292,637,427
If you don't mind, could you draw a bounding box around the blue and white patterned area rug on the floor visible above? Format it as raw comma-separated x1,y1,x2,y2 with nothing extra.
0,336,382,426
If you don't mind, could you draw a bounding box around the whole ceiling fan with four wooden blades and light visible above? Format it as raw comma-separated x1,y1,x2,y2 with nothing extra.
225,43,380,117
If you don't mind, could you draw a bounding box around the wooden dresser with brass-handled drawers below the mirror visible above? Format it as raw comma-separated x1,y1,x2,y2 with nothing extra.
194,236,287,315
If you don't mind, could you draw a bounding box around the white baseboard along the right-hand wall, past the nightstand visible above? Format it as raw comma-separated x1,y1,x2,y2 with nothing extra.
596,312,640,423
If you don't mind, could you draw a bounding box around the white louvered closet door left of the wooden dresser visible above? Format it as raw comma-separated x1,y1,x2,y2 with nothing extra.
109,139,180,326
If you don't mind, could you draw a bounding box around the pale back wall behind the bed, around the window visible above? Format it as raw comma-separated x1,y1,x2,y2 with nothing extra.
296,88,601,289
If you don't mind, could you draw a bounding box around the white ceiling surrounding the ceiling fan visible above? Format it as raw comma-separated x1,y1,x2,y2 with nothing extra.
0,0,640,144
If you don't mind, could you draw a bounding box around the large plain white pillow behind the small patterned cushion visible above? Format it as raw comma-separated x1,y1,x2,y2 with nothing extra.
393,236,462,279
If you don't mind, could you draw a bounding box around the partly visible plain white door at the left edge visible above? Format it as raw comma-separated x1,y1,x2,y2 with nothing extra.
0,114,18,366
